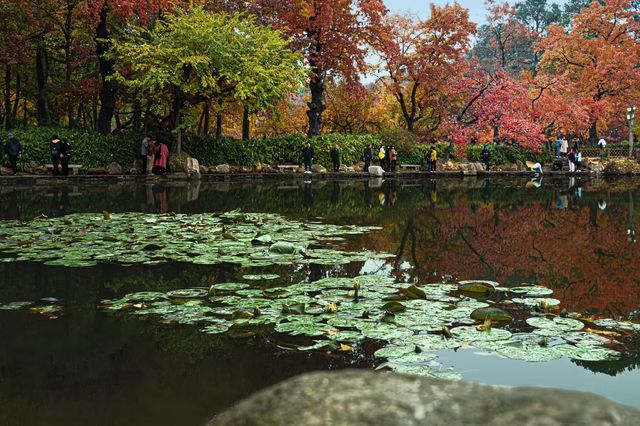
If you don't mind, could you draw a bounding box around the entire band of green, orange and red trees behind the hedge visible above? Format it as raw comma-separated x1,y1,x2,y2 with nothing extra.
0,0,640,153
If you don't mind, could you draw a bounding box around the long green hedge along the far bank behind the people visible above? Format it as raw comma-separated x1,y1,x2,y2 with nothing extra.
3,127,552,169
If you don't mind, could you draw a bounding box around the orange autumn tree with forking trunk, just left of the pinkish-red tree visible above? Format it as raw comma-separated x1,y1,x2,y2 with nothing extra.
375,4,476,132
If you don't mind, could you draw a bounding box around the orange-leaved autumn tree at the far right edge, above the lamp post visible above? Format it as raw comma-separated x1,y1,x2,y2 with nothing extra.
540,0,640,143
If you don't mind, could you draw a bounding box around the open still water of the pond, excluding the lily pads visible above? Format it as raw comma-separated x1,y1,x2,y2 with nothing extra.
0,179,640,425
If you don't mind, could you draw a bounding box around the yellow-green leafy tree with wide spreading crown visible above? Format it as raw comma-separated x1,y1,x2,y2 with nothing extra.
110,8,306,152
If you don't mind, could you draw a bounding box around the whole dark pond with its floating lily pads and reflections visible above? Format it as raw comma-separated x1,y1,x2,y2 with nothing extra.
0,178,640,425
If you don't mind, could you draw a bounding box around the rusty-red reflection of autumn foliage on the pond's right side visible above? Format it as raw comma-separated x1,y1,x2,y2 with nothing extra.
356,200,640,314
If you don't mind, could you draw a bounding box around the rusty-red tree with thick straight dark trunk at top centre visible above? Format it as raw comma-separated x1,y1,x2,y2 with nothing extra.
256,0,386,136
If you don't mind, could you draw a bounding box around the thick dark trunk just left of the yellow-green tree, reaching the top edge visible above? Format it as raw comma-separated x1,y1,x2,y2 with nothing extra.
95,1,118,135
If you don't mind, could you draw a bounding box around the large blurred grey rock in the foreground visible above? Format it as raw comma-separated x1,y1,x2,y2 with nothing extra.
209,371,640,426
